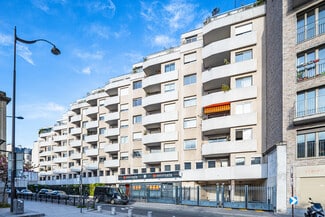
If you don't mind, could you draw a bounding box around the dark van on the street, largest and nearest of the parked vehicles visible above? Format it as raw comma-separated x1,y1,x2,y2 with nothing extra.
94,186,129,204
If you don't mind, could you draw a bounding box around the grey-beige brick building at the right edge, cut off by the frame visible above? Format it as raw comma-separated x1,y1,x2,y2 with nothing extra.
266,0,325,210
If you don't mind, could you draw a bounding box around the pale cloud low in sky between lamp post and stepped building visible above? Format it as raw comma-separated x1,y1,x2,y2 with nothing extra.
19,102,65,119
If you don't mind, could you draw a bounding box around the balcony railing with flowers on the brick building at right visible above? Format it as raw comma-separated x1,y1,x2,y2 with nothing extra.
297,59,325,82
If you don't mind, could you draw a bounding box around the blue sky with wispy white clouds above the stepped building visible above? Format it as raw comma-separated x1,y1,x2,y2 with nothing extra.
0,0,255,148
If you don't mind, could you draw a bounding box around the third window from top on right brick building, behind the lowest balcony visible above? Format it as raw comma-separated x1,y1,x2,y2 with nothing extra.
296,87,325,117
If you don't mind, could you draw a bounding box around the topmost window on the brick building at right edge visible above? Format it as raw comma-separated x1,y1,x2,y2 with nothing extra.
297,5,325,43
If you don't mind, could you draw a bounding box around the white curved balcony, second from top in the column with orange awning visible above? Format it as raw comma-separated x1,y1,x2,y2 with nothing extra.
202,32,257,60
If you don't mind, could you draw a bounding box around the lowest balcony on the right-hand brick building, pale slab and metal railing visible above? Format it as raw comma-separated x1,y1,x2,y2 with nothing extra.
293,107,325,125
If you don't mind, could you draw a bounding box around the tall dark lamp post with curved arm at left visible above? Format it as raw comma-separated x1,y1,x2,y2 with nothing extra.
10,27,61,212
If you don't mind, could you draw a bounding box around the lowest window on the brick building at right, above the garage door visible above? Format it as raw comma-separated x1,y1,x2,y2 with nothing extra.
297,131,325,158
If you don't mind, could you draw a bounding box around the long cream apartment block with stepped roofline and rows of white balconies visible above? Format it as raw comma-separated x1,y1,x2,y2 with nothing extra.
35,2,268,203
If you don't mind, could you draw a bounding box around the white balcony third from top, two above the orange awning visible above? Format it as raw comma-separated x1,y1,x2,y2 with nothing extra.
202,59,257,85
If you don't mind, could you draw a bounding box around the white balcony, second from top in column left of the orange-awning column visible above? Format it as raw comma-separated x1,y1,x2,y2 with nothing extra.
142,70,178,89
